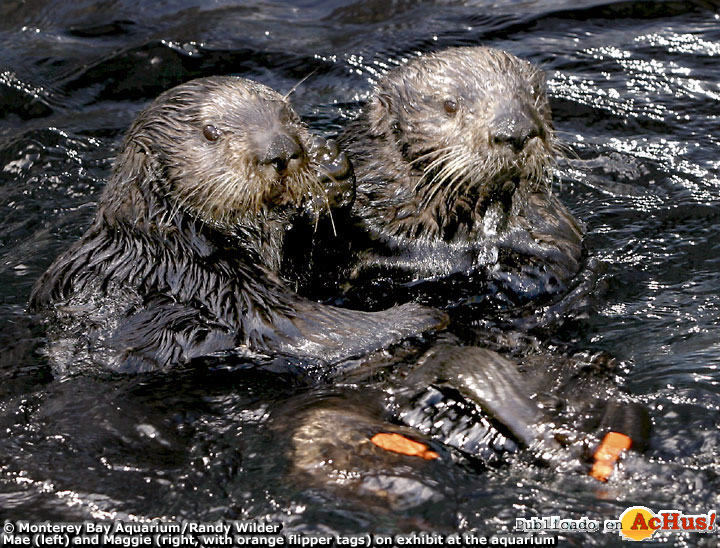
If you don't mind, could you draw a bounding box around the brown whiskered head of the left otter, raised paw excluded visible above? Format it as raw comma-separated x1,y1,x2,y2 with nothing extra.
110,77,347,231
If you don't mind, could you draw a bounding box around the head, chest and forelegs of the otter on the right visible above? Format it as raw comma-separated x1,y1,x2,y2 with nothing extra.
332,47,583,310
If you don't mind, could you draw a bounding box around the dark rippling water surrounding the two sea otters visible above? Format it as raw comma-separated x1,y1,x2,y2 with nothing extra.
0,0,720,545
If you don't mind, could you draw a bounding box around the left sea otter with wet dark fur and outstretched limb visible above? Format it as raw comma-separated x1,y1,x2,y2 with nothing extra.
30,77,444,371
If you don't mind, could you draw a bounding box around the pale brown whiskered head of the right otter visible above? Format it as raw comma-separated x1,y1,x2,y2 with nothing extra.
368,47,557,239
